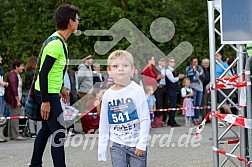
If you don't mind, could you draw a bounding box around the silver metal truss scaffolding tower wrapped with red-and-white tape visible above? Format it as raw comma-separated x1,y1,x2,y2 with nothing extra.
207,0,247,167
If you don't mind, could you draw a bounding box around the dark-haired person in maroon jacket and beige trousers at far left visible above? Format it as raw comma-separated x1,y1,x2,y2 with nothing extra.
4,59,26,140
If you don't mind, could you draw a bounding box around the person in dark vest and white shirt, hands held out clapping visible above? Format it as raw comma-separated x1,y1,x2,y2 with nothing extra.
165,57,185,127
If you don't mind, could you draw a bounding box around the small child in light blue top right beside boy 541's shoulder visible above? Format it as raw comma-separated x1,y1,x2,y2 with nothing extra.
145,86,156,128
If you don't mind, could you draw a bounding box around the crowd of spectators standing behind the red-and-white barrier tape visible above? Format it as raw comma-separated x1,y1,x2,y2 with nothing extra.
0,53,237,142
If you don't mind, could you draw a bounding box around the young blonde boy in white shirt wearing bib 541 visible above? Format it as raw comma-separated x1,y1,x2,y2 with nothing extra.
98,50,150,167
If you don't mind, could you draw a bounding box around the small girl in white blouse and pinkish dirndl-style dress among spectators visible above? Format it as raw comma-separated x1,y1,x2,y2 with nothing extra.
181,78,194,126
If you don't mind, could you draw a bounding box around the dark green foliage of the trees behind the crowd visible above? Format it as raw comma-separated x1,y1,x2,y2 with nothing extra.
0,0,215,72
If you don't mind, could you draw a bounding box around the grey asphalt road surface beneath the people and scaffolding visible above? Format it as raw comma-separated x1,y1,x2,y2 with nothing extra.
0,118,242,167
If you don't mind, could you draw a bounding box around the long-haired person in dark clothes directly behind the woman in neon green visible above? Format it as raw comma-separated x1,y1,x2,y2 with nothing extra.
24,57,42,139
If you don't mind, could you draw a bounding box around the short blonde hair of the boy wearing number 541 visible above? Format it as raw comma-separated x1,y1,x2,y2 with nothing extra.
107,50,134,66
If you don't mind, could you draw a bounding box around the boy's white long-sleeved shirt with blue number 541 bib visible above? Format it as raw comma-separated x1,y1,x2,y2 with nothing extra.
98,81,150,161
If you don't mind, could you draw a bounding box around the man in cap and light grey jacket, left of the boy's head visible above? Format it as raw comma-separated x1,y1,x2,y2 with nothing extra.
77,53,93,99
